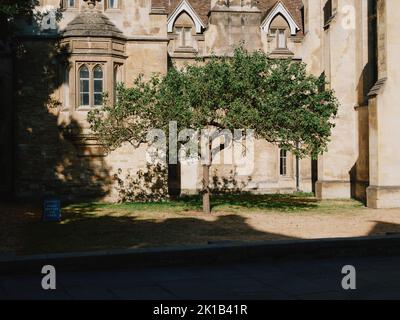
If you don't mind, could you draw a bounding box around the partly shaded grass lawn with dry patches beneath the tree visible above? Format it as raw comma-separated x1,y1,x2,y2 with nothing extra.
0,194,400,254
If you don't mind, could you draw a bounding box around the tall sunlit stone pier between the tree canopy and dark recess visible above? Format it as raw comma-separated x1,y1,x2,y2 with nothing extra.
303,0,360,198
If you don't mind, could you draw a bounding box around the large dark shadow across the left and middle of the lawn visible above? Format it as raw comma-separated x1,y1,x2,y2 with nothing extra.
18,205,298,254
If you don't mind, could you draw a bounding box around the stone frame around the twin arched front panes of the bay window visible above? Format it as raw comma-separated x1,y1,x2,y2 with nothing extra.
75,60,108,111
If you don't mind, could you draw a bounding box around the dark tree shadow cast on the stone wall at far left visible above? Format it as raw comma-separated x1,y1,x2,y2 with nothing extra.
14,39,111,200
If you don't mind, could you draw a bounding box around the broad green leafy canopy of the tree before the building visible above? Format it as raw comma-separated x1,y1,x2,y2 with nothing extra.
89,48,338,157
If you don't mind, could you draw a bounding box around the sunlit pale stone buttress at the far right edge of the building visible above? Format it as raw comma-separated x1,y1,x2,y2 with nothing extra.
367,0,400,208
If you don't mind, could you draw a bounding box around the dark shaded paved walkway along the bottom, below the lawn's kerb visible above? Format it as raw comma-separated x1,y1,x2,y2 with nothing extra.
0,255,400,300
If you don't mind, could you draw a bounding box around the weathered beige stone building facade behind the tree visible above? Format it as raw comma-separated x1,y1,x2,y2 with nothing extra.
0,0,400,208
